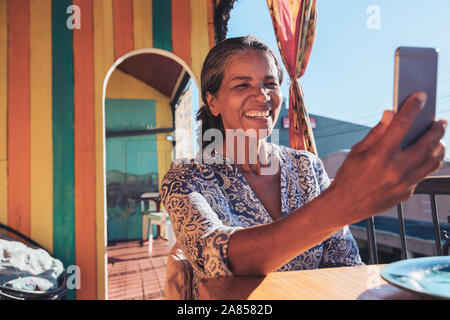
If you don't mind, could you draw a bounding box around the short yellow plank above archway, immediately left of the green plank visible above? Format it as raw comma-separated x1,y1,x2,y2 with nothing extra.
133,0,153,50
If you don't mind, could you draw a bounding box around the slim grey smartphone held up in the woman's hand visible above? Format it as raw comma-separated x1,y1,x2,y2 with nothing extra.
394,47,439,149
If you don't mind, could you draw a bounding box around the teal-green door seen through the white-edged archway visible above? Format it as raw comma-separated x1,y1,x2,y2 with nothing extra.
106,99,159,243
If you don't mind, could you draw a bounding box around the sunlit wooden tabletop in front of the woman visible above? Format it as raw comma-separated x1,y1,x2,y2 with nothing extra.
199,265,425,300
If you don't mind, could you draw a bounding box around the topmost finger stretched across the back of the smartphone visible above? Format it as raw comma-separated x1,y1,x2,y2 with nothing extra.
383,92,427,150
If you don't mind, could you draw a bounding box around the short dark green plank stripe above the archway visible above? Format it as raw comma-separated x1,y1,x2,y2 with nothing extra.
152,0,171,51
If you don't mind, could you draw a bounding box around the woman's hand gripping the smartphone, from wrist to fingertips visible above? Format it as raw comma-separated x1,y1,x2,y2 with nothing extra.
330,92,447,224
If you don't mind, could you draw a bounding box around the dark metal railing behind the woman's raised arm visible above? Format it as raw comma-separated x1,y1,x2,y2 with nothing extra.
366,176,450,264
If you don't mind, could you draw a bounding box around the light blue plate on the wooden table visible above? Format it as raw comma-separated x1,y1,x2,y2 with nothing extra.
380,256,450,299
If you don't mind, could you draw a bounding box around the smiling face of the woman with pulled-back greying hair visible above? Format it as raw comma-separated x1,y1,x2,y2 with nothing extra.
207,50,282,138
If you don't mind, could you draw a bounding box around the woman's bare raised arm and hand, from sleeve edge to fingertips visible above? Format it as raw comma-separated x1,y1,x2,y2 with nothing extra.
228,93,447,275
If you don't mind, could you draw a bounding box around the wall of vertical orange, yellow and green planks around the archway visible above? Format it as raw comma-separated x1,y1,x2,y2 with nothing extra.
0,0,214,299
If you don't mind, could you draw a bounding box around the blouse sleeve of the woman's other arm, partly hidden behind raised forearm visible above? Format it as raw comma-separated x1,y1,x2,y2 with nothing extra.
314,157,364,268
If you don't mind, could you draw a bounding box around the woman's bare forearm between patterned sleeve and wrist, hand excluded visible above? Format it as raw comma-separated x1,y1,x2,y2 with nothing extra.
228,185,351,275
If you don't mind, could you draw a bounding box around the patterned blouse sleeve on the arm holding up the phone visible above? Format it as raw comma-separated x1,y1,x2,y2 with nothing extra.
161,164,240,277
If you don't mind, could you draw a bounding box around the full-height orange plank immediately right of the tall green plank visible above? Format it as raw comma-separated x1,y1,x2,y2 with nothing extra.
73,0,97,300
